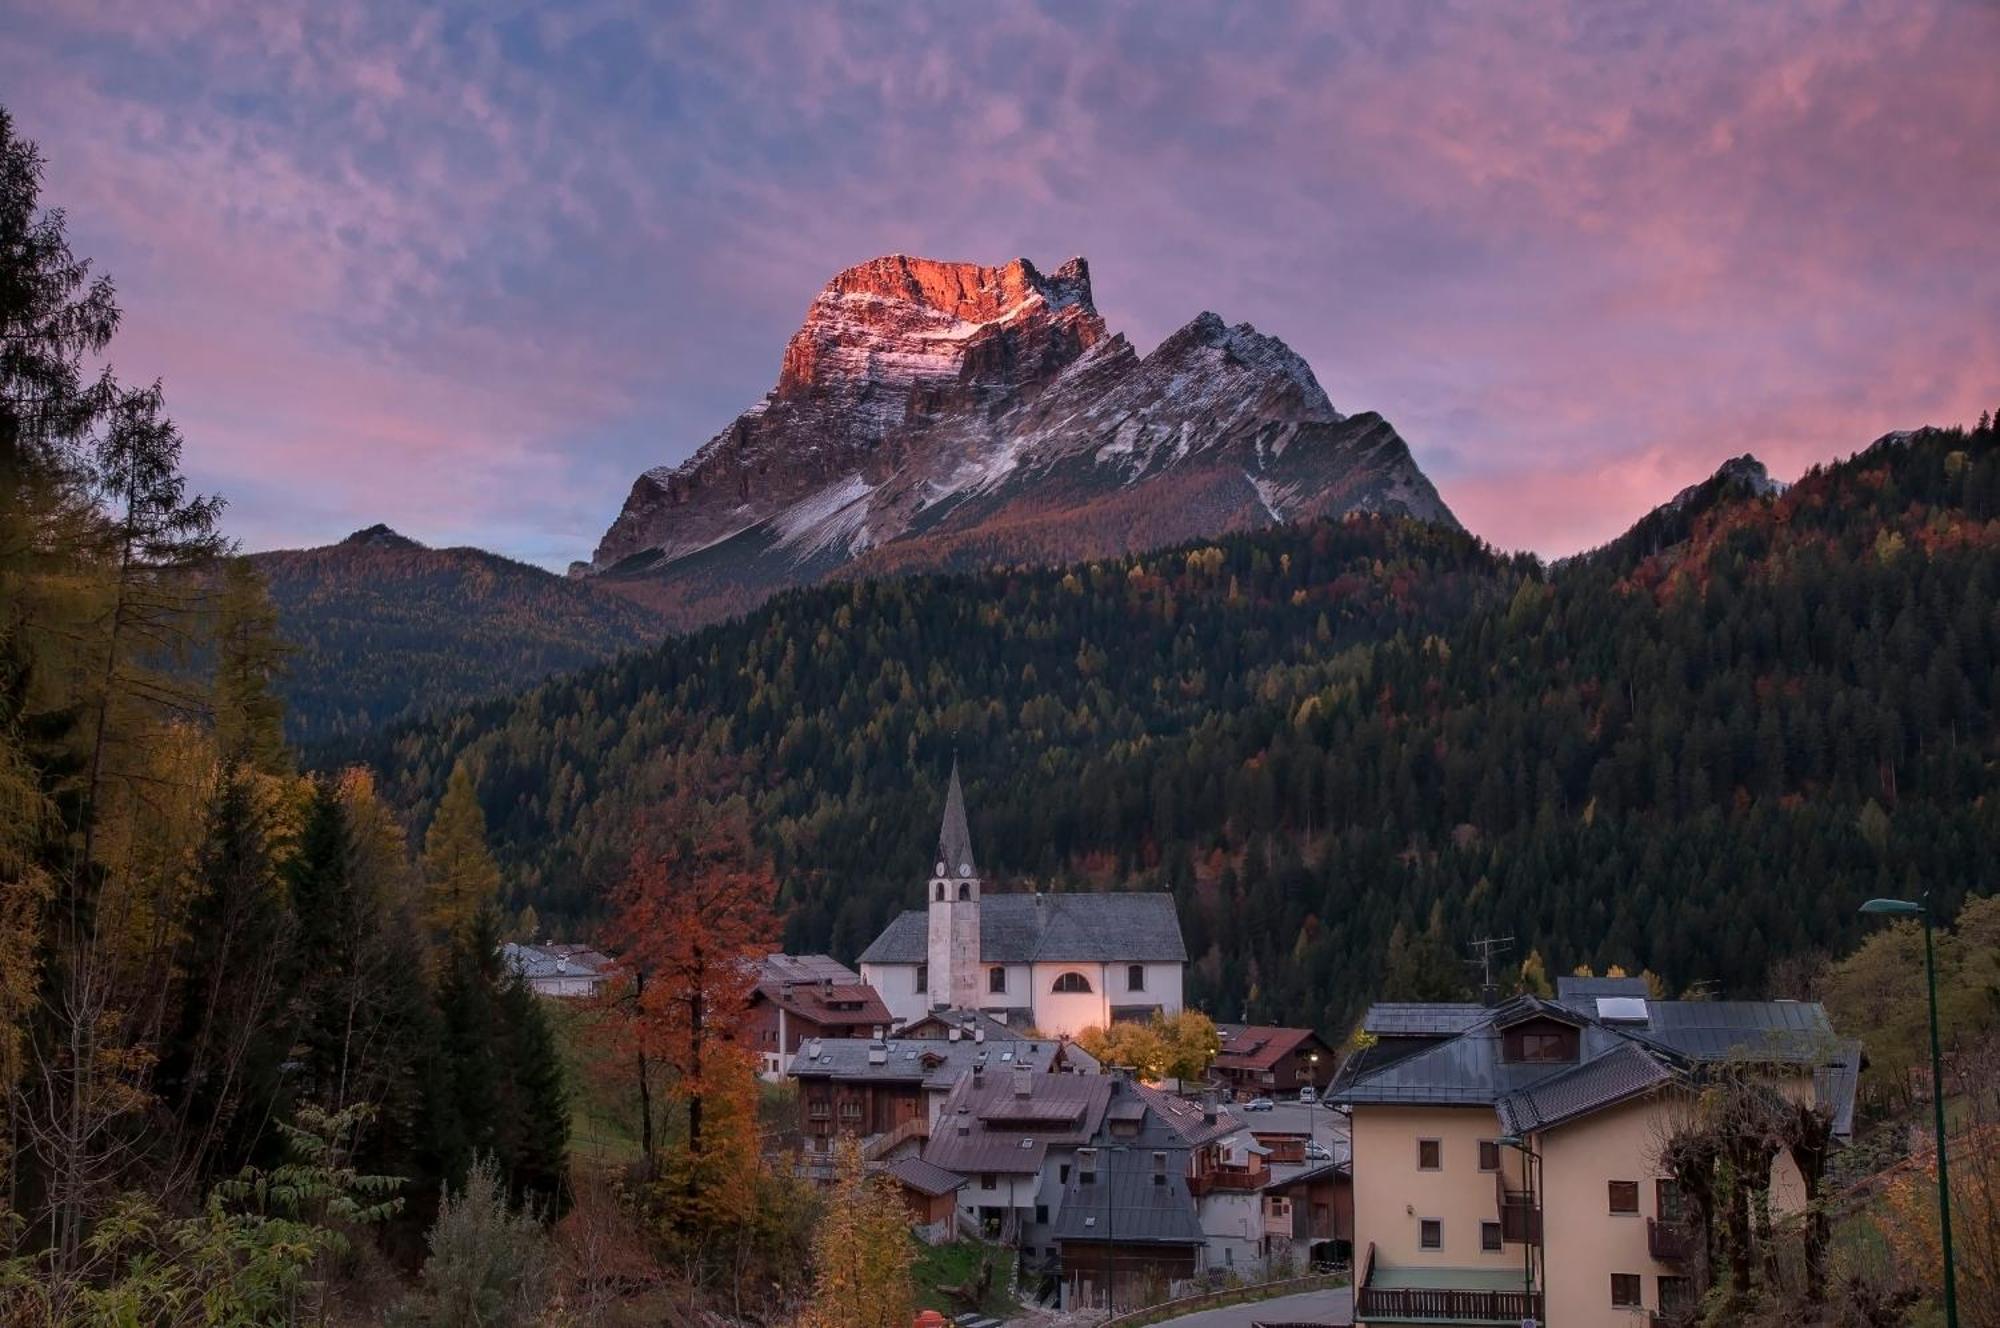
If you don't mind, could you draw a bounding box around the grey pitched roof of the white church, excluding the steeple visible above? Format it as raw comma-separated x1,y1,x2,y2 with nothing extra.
860,892,1188,964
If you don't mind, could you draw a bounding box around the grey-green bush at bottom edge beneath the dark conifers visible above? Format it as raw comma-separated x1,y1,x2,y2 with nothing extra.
394,1156,552,1328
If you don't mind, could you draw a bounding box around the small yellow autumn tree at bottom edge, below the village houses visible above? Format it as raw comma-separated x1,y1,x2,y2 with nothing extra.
800,1136,916,1328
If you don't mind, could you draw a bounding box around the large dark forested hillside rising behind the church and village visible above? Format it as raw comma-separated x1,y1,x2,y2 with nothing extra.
376,422,2000,1024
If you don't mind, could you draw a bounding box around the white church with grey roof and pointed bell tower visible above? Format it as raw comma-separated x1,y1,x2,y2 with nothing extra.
860,760,1188,1036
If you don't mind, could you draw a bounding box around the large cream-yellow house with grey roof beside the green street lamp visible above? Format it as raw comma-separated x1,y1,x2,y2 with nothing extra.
1332,978,1860,1328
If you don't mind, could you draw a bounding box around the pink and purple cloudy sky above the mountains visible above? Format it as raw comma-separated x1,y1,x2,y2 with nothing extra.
0,0,2000,568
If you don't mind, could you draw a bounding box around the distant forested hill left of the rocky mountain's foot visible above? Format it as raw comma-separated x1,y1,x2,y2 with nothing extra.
250,526,664,744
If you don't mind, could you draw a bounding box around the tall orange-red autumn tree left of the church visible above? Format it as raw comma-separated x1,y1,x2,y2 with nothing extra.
610,798,778,1220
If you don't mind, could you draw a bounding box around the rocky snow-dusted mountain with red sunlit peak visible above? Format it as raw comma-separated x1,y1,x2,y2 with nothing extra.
572,254,1456,626
